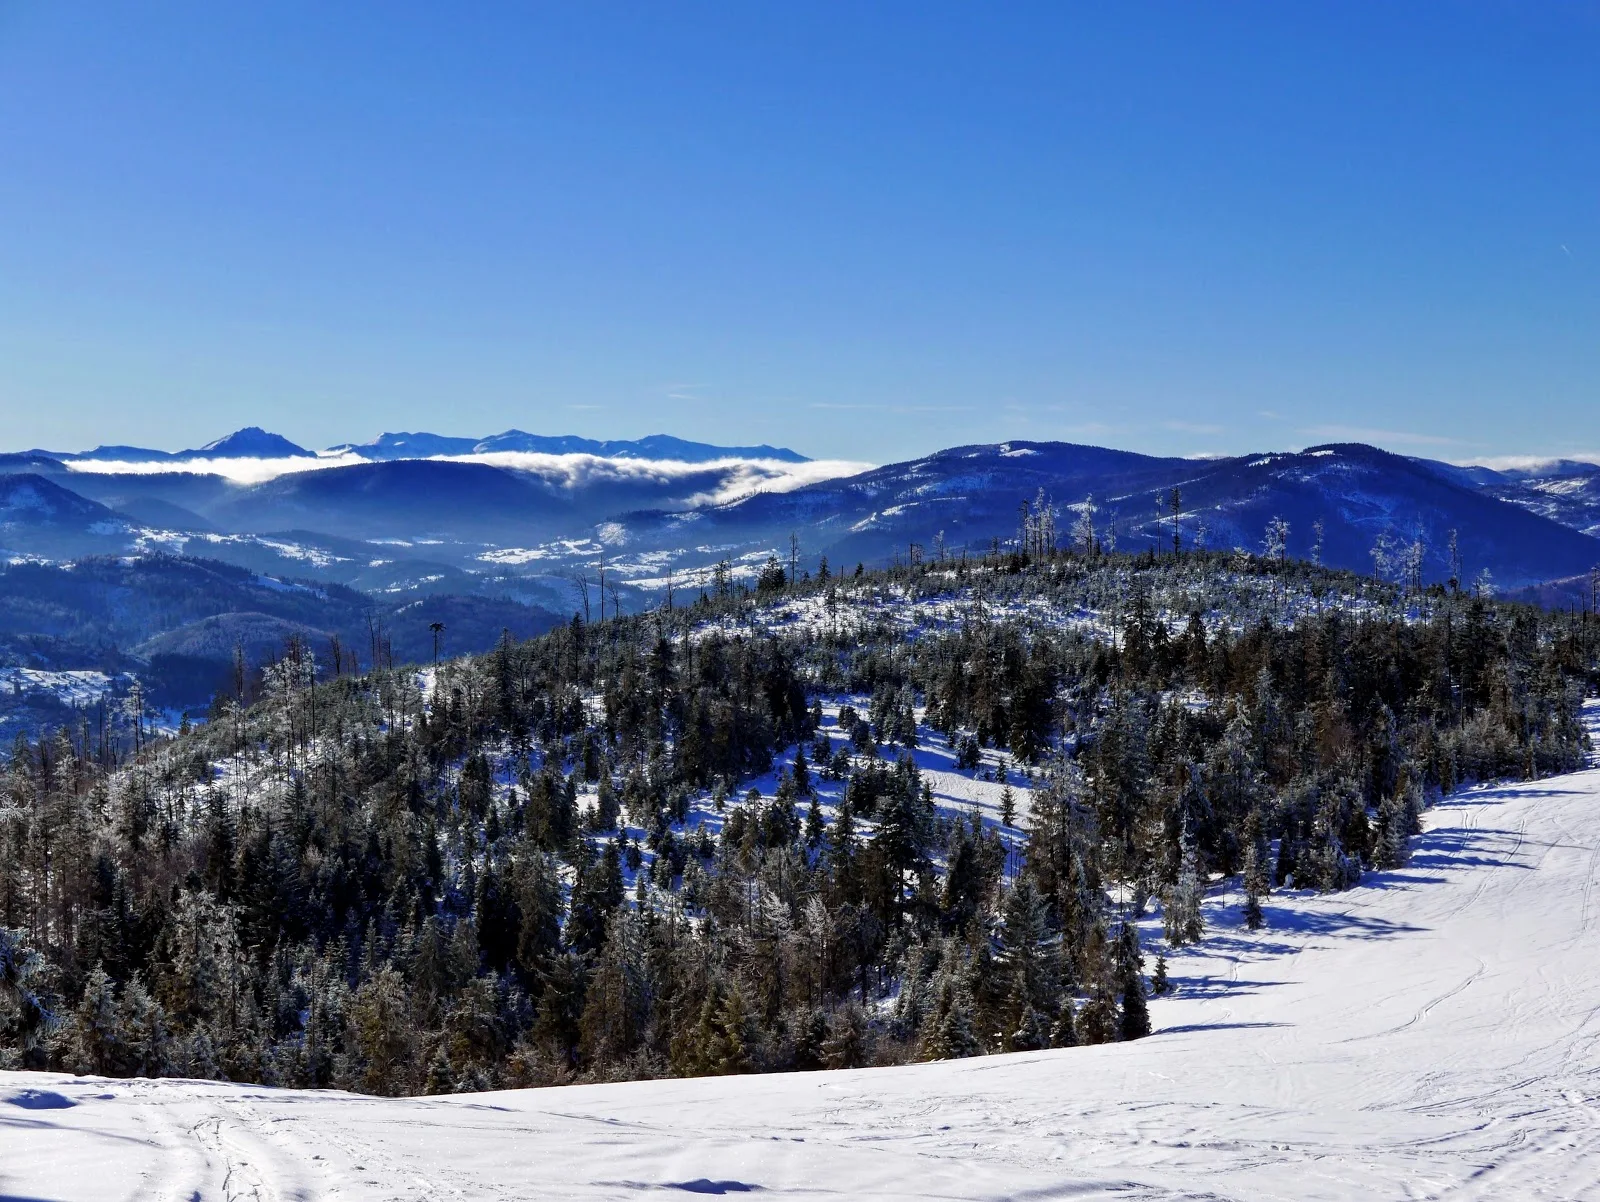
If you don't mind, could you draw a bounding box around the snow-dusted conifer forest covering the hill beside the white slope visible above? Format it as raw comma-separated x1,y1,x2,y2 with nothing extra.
0,544,1600,1095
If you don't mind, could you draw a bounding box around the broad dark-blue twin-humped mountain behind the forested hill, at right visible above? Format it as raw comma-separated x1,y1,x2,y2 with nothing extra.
611,442,1600,584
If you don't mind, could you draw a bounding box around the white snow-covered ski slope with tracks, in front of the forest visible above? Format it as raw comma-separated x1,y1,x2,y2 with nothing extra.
9,711,1600,1202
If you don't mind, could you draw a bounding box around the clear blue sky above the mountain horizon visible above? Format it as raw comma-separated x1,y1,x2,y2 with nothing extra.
0,0,1600,461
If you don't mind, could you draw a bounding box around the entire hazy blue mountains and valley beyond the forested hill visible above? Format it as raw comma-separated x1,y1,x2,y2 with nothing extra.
0,427,1600,713
